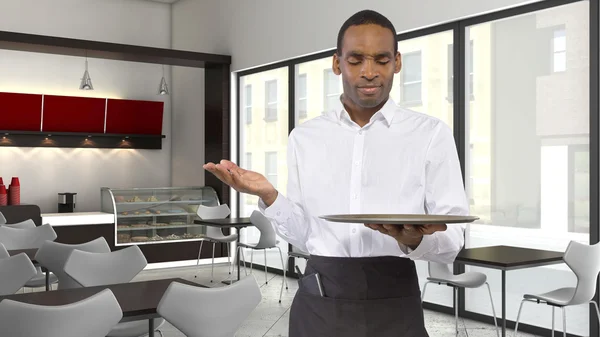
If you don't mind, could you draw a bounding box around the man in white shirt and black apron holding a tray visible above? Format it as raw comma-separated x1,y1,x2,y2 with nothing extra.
204,11,468,337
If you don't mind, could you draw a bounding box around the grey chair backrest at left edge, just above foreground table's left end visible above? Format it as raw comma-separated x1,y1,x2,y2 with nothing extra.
0,253,37,294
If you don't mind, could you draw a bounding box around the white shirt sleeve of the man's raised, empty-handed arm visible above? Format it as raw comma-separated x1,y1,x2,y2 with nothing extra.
258,131,309,251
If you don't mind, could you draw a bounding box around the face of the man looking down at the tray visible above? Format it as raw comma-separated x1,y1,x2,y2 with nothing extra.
333,24,402,108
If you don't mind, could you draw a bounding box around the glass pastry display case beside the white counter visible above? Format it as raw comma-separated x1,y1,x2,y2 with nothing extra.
101,187,219,246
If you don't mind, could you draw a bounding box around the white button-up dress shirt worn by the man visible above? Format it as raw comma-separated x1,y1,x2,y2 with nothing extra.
259,98,469,263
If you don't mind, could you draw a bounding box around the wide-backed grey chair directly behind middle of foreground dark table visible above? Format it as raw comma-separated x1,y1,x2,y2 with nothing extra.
64,246,165,337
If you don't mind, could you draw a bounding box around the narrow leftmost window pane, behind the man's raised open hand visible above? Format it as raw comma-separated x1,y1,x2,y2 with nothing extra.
239,67,289,272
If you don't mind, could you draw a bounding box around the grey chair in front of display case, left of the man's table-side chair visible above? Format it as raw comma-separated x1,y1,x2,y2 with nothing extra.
194,204,238,282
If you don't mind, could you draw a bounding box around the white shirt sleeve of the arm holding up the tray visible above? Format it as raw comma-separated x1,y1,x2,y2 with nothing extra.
402,122,469,264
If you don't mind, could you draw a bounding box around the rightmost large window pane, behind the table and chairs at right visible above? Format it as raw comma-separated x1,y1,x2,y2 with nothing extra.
465,1,590,336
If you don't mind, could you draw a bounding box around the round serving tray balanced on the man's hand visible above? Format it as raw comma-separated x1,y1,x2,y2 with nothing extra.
319,214,479,225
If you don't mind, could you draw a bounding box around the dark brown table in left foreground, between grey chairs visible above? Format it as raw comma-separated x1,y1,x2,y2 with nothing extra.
0,278,202,337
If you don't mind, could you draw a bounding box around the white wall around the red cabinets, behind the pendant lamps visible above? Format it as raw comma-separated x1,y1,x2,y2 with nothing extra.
0,0,171,212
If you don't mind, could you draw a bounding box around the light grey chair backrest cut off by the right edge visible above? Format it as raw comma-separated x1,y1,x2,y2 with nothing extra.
563,241,600,305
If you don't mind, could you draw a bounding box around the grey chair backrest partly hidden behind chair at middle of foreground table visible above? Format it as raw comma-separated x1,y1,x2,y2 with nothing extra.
35,236,110,289
